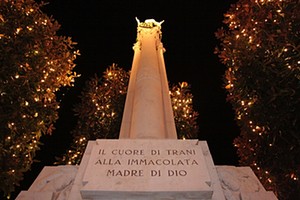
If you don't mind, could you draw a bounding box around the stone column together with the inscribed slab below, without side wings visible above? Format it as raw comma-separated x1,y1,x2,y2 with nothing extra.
81,19,213,199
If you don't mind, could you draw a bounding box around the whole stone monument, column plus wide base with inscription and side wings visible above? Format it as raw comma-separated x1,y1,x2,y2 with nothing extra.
17,19,276,200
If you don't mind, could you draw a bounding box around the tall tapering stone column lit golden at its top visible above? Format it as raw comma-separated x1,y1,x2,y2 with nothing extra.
119,19,177,139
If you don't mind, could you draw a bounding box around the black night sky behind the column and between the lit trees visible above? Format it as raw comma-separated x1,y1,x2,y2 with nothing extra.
18,0,239,197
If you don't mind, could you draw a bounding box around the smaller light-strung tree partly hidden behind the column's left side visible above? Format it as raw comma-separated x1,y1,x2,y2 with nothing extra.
58,64,129,164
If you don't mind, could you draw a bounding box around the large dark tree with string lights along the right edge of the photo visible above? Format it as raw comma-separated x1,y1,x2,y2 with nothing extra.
216,0,300,199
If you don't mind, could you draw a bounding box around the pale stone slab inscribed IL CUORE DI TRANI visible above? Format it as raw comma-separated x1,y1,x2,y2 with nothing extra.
81,139,213,199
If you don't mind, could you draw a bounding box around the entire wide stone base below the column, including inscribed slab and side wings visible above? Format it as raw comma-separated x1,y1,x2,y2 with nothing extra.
17,139,276,200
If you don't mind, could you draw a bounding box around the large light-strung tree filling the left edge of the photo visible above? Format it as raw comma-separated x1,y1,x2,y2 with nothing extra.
0,0,79,198
